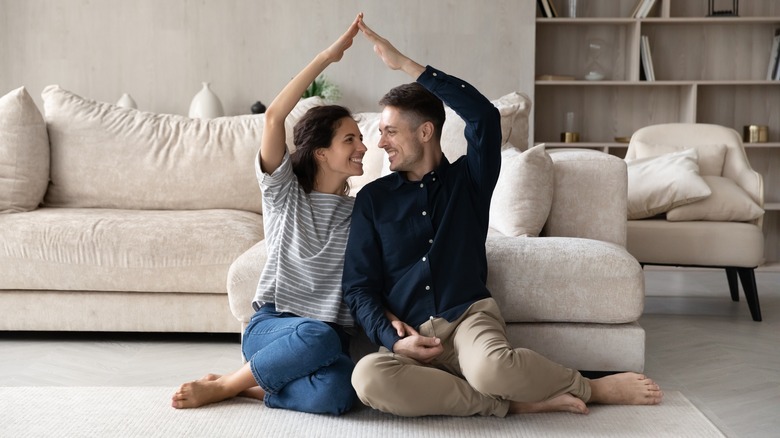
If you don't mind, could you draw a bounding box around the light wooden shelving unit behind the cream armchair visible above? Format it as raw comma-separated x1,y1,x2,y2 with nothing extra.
533,0,780,269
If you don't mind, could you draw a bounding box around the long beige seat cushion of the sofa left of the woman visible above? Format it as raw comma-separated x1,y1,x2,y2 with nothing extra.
0,208,263,294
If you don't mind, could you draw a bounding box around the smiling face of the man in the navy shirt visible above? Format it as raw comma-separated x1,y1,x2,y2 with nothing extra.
378,106,428,179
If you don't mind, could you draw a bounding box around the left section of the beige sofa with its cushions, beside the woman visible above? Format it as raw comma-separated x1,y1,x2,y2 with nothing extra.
0,86,282,332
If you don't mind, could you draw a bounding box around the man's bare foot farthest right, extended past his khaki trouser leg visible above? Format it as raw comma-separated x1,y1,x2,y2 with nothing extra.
589,373,664,405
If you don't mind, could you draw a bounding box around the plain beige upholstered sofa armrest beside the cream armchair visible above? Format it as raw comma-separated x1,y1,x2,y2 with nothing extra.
542,149,628,247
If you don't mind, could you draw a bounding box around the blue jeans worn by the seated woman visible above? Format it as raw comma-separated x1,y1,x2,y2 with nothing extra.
241,303,356,415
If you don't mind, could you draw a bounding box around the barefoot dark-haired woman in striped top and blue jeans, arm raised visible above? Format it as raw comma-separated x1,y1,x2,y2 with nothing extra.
172,15,366,415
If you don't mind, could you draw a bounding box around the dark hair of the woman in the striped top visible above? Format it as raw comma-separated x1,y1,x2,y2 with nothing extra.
290,105,352,194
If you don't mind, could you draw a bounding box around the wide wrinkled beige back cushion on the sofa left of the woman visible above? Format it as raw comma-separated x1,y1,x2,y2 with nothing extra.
42,85,321,212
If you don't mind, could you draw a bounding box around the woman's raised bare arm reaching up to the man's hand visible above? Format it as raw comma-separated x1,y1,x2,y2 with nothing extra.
260,13,363,174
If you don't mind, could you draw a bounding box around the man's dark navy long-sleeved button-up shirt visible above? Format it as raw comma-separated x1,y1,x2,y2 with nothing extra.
342,66,501,351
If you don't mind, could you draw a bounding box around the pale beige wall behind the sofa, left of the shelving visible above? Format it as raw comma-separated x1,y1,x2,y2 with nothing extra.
0,0,536,115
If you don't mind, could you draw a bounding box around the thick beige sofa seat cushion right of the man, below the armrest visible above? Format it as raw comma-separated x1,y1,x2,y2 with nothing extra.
486,236,644,324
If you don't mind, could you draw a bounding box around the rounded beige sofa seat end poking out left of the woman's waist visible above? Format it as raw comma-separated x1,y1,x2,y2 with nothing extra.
227,240,268,327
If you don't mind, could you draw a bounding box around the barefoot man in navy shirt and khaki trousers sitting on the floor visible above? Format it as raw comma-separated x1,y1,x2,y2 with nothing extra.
343,19,663,416
